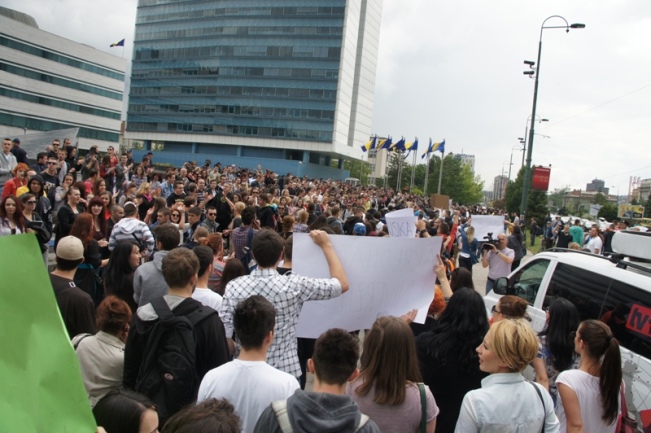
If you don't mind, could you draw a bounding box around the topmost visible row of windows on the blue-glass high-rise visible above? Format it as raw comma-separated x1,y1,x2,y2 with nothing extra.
138,5,345,24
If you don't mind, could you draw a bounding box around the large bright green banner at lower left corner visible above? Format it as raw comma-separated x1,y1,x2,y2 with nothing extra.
0,234,96,433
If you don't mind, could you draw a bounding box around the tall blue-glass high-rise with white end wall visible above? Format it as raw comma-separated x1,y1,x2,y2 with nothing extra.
126,0,382,177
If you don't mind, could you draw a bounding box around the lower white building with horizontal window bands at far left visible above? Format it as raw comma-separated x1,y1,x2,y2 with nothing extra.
0,7,126,152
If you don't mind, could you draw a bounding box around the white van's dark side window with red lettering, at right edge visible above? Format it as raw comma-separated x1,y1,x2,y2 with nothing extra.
600,280,651,358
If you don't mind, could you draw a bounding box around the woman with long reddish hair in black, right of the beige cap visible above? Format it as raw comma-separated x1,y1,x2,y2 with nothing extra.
70,213,108,307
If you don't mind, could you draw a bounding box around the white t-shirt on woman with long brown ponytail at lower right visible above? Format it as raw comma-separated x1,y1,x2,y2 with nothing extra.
556,370,621,433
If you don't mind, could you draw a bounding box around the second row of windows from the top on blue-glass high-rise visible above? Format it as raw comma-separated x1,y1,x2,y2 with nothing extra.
136,26,343,42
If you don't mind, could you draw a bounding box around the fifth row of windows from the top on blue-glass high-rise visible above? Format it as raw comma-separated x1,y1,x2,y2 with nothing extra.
131,81,337,101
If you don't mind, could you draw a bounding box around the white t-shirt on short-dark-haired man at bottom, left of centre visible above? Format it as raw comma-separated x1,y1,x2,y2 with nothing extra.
197,359,299,433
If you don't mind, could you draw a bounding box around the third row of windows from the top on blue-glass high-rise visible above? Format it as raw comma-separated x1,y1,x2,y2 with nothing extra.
135,45,341,61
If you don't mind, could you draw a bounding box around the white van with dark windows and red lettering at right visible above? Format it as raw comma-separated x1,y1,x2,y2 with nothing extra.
484,230,651,428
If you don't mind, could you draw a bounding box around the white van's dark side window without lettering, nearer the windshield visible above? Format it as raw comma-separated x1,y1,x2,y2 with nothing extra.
543,263,610,321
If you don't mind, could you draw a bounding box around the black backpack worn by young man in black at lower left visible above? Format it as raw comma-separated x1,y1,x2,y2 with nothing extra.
135,297,215,420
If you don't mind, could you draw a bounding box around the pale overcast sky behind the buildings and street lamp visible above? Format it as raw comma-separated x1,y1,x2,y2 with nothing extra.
2,0,651,195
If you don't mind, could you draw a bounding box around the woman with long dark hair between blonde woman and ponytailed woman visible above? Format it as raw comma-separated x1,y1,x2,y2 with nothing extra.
533,298,580,404
